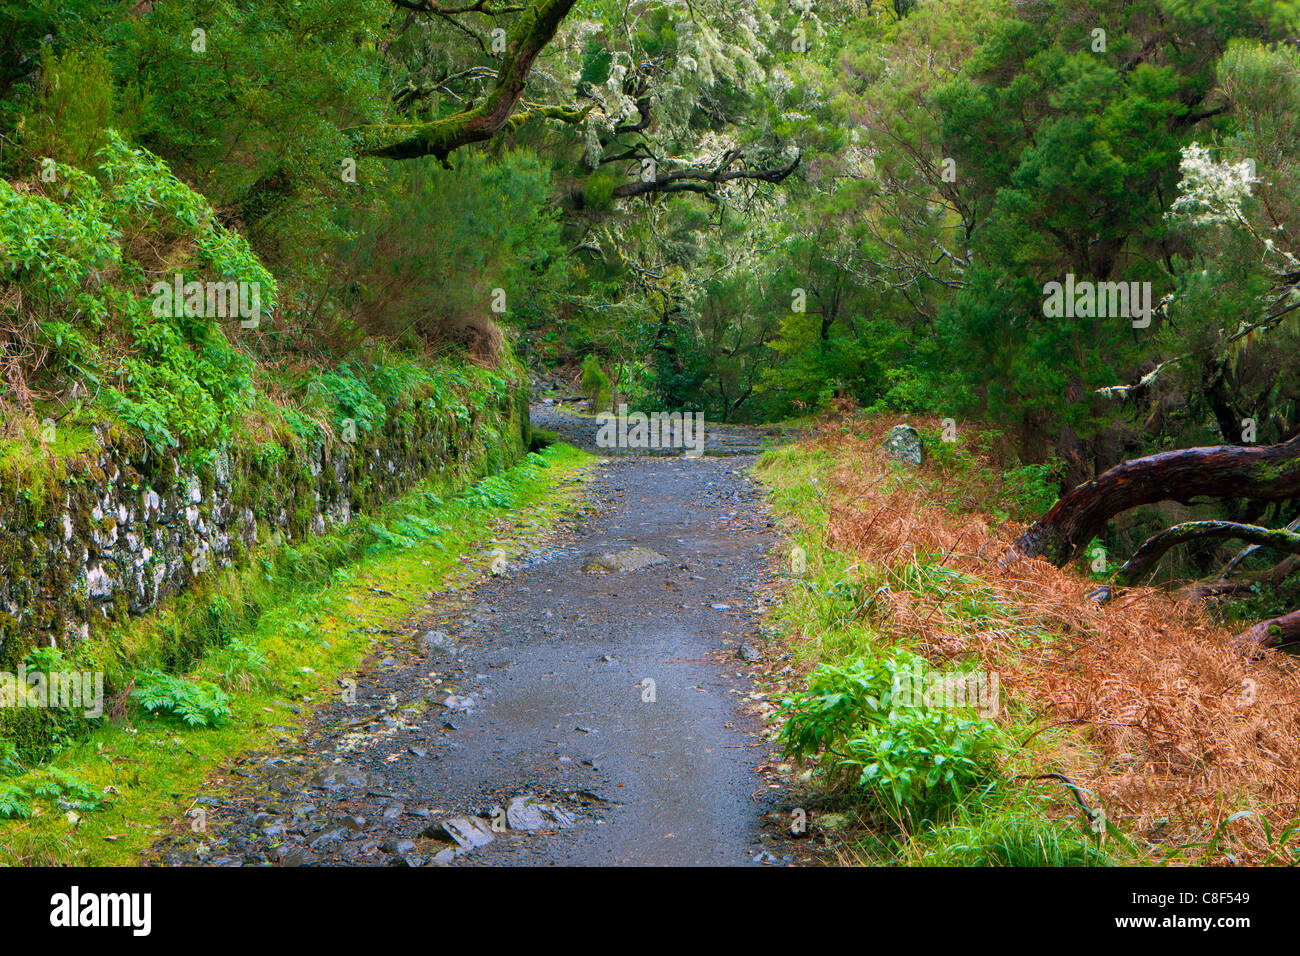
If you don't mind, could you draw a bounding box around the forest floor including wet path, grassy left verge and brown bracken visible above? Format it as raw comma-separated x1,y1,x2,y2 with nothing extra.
15,410,1300,866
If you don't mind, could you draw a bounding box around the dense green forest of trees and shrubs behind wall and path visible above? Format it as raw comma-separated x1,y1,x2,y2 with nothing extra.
0,0,1300,874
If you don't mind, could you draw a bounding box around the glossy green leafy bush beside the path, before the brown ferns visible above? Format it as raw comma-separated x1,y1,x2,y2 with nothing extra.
781,654,996,825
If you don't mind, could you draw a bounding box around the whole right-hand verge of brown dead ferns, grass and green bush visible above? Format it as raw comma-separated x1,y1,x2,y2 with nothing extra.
758,415,1300,866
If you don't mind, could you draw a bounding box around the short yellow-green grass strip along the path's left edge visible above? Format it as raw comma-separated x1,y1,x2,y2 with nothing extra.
0,445,593,866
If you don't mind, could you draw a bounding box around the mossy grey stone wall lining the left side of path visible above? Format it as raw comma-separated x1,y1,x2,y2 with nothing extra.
0,382,528,665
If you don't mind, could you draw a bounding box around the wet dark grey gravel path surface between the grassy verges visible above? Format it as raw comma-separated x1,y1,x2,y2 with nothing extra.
147,458,788,866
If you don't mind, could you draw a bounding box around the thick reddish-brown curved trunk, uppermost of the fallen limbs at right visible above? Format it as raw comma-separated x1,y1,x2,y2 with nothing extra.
1002,434,1300,567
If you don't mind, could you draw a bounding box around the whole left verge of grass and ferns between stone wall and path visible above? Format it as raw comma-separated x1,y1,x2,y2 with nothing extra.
0,445,592,865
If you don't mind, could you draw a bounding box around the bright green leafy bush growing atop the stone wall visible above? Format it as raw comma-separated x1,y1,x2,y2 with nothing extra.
0,129,277,458
